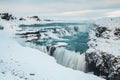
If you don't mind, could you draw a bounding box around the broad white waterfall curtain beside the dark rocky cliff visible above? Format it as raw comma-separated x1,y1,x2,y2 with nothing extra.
53,48,86,71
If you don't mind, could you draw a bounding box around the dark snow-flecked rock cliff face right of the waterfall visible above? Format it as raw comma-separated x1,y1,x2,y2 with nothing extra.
85,52,120,80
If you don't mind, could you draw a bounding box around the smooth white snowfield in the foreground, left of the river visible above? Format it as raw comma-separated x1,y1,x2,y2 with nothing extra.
0,16,103,80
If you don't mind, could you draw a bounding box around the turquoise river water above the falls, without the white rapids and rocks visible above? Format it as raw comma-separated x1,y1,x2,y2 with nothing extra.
20,23,88,53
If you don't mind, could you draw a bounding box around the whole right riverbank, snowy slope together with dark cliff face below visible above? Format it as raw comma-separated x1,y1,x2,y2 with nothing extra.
86,17,120,80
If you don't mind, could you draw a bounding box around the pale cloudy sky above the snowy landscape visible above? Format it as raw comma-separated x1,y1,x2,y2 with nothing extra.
0,0,120,20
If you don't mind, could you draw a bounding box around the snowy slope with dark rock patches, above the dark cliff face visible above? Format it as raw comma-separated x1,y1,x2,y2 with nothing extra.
88,17,120,56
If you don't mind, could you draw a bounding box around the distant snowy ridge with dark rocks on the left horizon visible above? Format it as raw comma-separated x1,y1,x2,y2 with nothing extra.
0,13,53,25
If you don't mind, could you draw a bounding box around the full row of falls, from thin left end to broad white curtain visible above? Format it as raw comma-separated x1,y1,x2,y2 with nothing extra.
24,43,86,72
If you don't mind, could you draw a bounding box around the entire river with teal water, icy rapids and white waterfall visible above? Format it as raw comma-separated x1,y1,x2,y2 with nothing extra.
18,23,89,71
